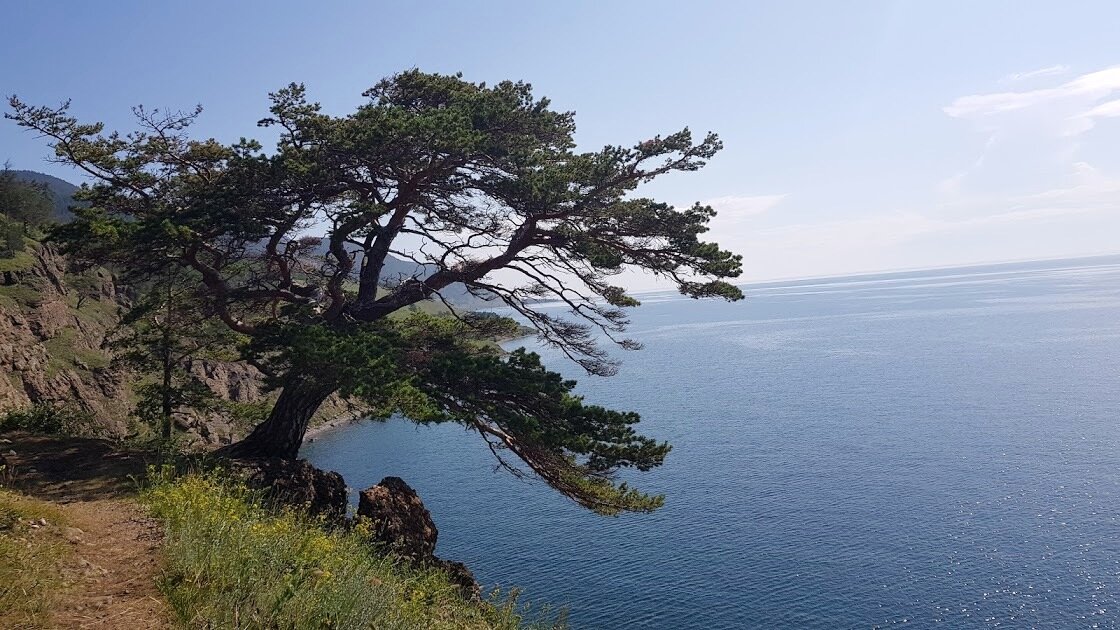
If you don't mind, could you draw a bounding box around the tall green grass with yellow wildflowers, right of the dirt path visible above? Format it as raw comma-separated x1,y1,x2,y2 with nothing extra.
144,469,564,630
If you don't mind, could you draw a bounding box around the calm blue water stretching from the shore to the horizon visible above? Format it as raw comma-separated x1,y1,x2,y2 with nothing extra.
304,258,1120,629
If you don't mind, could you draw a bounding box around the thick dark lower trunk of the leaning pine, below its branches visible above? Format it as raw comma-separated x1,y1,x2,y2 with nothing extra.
222,377,335,460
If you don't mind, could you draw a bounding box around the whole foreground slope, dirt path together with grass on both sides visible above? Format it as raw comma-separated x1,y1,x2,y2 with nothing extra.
0,433,562,630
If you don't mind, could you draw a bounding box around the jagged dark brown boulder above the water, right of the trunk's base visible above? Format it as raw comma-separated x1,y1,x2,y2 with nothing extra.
357,476,482,600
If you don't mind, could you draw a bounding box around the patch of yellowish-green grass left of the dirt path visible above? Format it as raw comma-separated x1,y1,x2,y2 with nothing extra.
0,486,69,628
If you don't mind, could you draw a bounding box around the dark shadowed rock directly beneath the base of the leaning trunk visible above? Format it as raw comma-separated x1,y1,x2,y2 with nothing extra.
230,460,348,524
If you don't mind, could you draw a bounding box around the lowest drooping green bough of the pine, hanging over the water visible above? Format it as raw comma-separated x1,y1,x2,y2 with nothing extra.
249,313,670,515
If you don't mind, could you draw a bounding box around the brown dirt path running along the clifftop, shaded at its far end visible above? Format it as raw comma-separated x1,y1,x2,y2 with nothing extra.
0,434,170,629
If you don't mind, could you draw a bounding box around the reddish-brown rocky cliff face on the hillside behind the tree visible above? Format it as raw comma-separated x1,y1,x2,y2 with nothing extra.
0,244,274,447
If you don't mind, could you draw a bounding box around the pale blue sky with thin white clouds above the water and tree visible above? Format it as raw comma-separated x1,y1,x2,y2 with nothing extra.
0,0,1120,286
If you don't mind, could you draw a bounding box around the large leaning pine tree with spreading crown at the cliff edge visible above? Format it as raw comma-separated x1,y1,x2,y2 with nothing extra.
7,71,743,513
